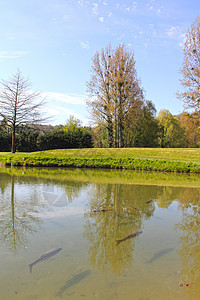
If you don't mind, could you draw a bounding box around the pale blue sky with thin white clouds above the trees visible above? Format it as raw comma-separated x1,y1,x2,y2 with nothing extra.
0,0,200,125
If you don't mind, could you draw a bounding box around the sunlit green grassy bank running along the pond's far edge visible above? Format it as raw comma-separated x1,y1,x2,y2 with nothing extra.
0,148,200,173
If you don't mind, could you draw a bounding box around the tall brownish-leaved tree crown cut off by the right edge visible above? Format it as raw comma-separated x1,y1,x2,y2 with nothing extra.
178,17,200,111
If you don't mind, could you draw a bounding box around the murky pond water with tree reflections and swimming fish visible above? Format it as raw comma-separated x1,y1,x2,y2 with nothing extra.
0,168,200,300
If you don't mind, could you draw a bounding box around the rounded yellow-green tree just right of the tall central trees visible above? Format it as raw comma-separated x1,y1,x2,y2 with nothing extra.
157,109,187,148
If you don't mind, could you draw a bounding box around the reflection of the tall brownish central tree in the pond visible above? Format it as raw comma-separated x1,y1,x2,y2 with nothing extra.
84,184,155,276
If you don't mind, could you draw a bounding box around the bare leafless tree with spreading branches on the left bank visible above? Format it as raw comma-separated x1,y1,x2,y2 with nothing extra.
0,70,47,153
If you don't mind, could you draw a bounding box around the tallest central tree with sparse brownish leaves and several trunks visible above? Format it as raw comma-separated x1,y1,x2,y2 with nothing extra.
87,44,143,147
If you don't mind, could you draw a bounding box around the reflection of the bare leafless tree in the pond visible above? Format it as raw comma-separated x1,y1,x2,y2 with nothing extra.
0,175,42,253
